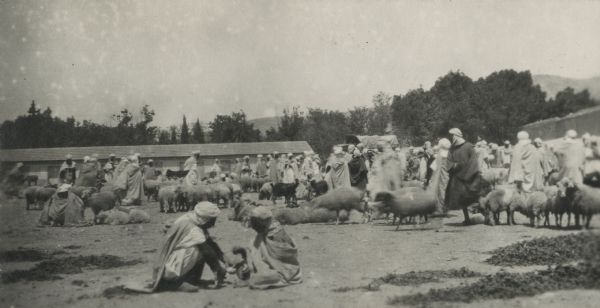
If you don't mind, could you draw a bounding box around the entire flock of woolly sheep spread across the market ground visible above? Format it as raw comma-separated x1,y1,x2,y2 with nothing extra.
19,168,600,229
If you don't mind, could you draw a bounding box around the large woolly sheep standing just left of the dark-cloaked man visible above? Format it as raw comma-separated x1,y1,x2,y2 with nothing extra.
375,187,437,231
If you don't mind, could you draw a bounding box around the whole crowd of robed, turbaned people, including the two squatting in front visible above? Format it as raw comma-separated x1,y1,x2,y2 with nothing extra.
4,128,600,292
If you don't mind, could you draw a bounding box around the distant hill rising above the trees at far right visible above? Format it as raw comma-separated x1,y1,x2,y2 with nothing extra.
532,75,600,100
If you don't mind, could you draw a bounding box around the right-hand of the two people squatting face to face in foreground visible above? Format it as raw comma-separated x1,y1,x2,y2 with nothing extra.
233,206,302,289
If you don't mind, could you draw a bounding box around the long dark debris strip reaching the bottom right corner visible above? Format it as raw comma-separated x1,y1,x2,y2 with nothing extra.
388,263,600,306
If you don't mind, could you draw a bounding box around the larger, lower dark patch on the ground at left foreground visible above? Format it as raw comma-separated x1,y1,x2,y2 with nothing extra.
2,255,142,283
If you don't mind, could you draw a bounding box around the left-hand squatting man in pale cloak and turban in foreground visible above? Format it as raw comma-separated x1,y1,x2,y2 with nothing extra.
129,201,226,293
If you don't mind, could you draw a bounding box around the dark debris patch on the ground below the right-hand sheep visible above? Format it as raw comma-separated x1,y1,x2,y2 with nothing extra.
486,232,600,266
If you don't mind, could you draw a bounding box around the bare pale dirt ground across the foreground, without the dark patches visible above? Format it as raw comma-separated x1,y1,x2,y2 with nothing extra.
0,194,600,308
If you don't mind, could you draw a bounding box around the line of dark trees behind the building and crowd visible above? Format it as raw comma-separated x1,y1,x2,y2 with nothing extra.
0,70,598,155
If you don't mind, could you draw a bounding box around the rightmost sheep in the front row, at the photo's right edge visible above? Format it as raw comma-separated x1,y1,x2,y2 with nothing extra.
560,179,600,229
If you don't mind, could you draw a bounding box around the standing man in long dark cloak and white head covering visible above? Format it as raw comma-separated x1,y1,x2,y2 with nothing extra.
446,128,481,224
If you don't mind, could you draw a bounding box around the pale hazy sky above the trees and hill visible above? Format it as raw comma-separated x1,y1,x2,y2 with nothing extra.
0,0,600,127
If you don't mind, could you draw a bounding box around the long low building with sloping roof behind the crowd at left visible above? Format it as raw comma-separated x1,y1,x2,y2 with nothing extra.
0,141,312,183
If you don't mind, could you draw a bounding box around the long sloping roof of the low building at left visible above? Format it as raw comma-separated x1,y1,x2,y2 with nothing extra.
0,141,312,162
